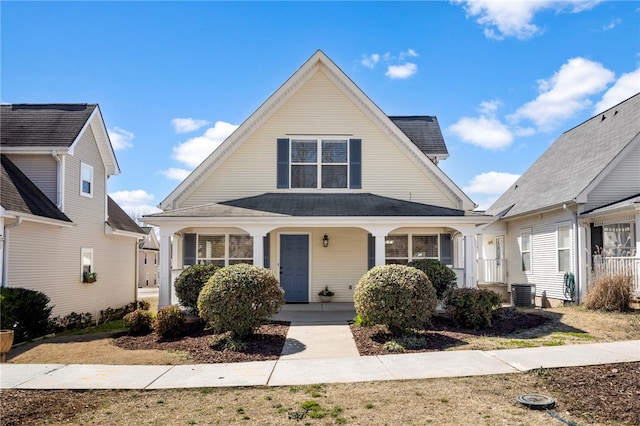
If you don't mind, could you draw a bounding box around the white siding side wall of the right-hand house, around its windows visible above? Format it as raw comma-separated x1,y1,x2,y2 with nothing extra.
505,210,576,300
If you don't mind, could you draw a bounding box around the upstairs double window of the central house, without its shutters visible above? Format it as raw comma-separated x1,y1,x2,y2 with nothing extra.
290,138,349,189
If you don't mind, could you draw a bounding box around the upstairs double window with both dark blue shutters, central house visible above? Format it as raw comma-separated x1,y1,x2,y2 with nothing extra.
277,138,362,189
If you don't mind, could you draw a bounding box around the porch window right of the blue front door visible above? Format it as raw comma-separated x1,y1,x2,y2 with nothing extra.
384,234,450,265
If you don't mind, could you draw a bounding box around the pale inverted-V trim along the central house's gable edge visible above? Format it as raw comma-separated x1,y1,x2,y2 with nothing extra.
159,50,476,210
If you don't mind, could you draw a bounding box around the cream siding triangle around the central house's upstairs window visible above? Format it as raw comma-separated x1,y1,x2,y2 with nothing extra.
178,71,459,208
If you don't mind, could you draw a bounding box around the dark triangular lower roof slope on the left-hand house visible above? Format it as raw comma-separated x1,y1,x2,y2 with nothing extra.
0,155,71,223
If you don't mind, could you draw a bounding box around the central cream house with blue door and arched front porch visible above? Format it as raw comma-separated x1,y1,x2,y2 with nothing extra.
143,51,490,306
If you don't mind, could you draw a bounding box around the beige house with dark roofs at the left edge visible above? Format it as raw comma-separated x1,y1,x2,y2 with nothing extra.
0,104,144,316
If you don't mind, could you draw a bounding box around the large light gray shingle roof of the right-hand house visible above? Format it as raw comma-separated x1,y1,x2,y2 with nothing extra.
487,93,640,218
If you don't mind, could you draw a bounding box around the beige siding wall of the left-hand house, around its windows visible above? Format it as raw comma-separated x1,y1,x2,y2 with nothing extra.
8,127,137,317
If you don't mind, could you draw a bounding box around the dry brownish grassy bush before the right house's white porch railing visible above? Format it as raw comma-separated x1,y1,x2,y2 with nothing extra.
584,274,633,312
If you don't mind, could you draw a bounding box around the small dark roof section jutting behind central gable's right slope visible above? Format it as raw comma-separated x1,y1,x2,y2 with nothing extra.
389,115,449,157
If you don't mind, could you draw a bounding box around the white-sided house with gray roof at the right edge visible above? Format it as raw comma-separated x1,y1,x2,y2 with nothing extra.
478,94,640,306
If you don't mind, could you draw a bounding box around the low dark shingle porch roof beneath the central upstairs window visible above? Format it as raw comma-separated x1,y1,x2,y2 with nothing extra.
148,193,464,217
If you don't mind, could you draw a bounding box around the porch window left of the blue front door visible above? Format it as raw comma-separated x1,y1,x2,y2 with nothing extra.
196,234,253,266
